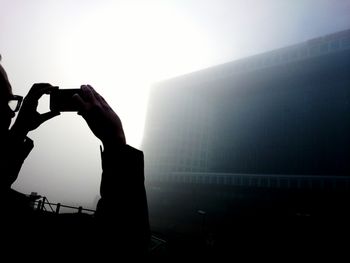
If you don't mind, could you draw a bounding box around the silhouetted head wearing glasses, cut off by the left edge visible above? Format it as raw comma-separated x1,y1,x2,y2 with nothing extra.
0,55,18,134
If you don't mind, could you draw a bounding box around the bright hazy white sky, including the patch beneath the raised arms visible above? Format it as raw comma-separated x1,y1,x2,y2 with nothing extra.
0,0,350,208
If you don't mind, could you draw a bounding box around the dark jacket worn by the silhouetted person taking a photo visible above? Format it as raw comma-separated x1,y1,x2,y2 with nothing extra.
1,135,150,258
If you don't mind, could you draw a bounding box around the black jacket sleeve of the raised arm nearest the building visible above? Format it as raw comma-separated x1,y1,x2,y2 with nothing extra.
96,145,150,251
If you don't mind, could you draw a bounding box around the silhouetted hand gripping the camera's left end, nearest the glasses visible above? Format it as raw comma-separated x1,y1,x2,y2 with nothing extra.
11,83,60,137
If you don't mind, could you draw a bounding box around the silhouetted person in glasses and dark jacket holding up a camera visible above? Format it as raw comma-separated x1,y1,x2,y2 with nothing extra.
0,56,150,260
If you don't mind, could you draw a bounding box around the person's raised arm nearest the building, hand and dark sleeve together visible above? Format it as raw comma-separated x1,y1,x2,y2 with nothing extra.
74,85,150,252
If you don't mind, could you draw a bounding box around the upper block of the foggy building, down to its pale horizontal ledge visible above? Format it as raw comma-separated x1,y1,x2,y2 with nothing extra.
142,30,350,188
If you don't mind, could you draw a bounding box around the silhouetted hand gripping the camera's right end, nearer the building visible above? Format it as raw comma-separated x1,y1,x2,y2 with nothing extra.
73,85,126,148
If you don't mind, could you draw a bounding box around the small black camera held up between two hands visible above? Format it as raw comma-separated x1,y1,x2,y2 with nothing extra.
50,89,81,112
